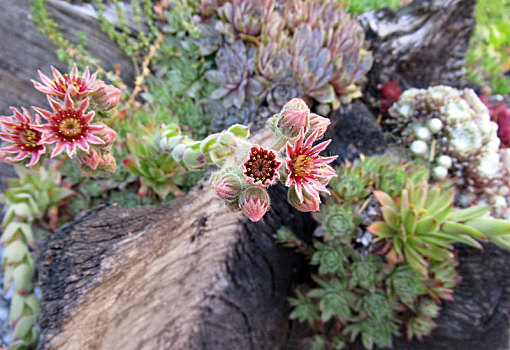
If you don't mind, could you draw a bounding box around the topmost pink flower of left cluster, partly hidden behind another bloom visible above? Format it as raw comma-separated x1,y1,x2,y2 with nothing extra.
32,64,100,100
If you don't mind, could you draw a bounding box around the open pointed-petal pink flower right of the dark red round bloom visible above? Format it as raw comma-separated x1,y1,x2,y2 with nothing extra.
285,129,338,202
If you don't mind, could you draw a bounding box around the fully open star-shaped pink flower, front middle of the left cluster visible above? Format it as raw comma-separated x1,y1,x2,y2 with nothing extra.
32,94,105,158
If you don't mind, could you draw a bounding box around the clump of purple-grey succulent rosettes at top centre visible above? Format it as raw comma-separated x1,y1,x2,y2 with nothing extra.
196,0,372,131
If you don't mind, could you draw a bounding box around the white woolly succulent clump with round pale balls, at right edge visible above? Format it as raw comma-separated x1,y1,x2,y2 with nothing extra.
387,86,510,217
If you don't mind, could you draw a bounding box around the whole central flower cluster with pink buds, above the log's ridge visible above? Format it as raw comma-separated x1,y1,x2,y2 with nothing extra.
206,98,337,221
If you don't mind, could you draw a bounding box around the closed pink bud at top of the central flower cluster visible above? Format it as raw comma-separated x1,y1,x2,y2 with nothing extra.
277,98,310,138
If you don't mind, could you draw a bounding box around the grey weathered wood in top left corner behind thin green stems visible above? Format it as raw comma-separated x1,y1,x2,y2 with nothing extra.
0,0,134,115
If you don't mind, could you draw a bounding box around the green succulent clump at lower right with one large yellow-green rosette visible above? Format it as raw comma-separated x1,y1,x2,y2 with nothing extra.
276,156,510,349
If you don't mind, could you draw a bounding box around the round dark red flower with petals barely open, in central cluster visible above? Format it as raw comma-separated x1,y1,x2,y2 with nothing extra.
244,147,281,184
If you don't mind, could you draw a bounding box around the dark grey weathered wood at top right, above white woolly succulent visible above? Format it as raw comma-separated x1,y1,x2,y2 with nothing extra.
360,0,476,96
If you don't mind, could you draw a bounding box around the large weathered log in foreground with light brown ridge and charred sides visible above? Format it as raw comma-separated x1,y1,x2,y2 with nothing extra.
35,176,312,350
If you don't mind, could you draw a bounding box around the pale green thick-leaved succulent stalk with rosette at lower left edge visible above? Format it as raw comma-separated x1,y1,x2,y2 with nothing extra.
0,163,73,349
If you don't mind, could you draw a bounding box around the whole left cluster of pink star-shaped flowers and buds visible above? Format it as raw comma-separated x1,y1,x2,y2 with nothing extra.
0,65,121,175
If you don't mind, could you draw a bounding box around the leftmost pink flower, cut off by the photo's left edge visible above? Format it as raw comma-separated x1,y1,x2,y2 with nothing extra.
0,107,46,166
